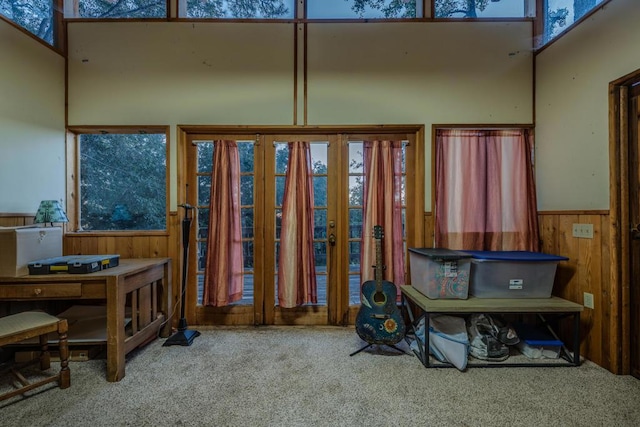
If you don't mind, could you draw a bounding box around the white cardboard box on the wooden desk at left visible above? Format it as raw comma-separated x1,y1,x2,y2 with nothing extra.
0,226,62,277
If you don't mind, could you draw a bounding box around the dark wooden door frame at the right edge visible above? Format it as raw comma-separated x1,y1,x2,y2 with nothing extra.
608,69,640,375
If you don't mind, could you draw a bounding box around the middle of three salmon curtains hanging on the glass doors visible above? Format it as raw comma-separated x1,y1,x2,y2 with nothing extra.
278,141,318,308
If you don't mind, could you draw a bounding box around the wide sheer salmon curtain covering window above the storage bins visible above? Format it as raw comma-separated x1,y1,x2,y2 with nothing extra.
435,129,540,252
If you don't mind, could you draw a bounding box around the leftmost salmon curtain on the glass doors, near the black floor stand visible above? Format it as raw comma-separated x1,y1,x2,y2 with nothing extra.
203,141,244,307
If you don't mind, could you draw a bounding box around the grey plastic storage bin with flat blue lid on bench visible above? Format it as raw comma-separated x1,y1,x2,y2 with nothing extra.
465,251,569,298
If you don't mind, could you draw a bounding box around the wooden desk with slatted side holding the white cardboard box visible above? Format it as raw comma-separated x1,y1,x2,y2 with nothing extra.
0,258,171,382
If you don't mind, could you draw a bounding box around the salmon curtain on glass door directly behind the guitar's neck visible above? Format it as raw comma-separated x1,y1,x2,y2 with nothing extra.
360,141,405,296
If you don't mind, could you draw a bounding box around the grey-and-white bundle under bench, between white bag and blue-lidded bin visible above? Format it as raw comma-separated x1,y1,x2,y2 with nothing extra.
467,314,509,362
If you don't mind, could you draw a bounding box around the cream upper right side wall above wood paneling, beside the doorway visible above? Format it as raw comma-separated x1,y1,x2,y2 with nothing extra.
536,0,640,211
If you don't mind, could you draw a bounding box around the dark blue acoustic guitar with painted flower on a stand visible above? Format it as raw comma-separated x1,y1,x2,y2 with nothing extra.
356,225,405,346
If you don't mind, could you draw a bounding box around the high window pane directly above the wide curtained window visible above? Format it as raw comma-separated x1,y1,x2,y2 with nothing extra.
435,0,524,18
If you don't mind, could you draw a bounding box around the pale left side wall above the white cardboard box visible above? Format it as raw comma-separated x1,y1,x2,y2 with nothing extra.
0,19,65,213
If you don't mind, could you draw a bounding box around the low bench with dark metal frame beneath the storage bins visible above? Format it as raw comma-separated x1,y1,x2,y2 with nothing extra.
400,286,583,368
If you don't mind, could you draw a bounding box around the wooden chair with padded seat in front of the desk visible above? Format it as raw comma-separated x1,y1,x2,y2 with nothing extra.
0,311,71,401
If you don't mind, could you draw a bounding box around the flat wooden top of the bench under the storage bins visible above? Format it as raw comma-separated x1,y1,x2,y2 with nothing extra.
400,285,583,313
